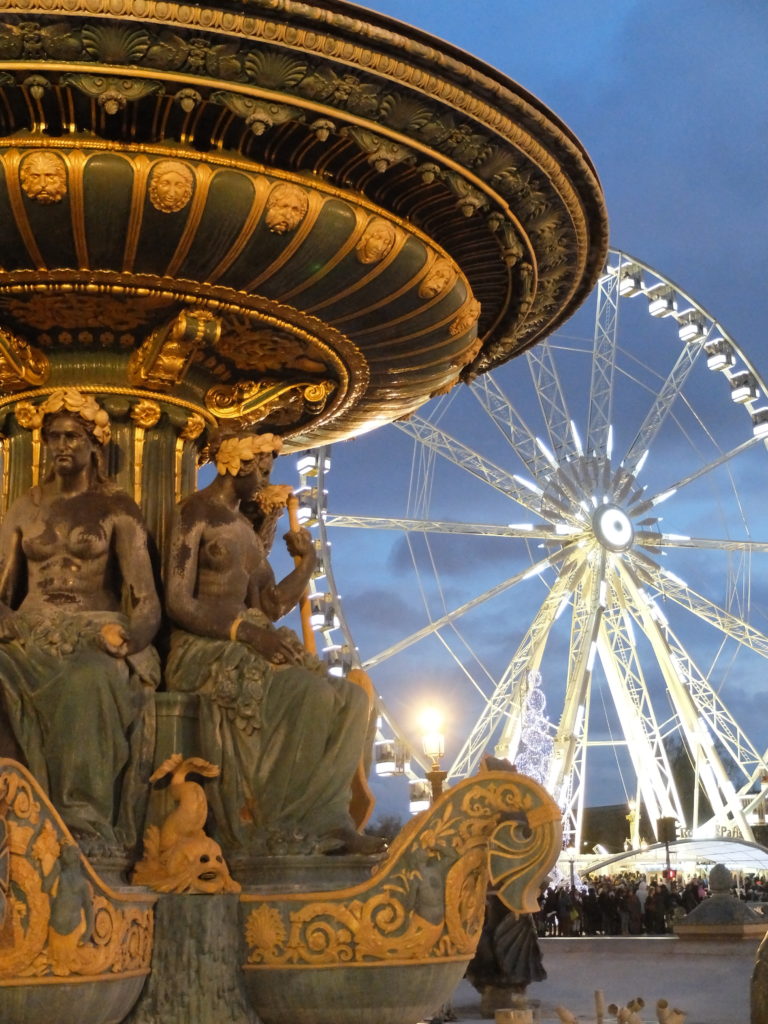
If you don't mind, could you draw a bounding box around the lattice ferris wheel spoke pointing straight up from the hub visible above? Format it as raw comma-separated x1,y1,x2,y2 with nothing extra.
587,258,622,456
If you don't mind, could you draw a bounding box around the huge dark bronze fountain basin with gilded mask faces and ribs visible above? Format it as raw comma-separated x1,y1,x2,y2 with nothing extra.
0,0,606,449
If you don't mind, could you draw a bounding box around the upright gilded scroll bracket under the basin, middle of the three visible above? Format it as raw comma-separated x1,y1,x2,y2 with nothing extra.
128,309,221,391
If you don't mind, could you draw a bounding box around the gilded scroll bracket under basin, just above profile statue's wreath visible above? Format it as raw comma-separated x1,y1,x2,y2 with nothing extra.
205,380,336,426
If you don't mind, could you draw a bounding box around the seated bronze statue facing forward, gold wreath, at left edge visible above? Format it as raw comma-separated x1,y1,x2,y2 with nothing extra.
0,389,161,851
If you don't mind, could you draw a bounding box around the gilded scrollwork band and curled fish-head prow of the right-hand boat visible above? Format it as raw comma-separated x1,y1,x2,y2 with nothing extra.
241,771,562,971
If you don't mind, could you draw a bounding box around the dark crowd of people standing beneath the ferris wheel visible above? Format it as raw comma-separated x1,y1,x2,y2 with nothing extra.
536,873,768,938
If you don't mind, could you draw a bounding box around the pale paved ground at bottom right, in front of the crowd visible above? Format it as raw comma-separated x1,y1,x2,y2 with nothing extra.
436,936,768,1024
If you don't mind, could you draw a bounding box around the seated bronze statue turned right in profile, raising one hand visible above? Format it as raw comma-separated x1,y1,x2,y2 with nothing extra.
166,434,382,858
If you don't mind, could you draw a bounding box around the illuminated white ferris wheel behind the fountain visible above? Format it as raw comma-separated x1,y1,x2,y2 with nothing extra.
300,251,768,852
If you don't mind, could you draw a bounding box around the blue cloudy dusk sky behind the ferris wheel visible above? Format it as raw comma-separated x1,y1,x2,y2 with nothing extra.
279,0,768,814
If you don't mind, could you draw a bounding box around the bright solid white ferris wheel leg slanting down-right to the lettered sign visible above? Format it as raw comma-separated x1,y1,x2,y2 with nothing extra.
620,565,752,837
